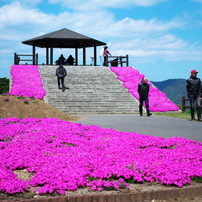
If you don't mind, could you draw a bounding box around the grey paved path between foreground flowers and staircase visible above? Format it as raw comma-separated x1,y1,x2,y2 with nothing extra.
74,114,202,142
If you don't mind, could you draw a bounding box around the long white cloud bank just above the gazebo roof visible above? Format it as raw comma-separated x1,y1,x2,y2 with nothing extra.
0,2,186,40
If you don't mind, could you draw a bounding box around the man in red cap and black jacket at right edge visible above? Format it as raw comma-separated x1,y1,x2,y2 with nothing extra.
186,70,201,121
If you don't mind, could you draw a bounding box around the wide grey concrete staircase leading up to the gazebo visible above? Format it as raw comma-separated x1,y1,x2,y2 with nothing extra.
39,65,139,114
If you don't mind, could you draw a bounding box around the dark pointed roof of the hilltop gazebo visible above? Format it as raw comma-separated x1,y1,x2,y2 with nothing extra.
22,28,106,48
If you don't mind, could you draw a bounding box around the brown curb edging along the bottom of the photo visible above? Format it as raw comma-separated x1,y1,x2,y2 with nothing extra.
0,186,202,202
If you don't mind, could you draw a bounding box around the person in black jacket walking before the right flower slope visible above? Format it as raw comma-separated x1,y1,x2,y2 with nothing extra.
138,77,152,116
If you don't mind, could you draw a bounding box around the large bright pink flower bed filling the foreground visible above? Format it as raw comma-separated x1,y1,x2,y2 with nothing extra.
0,118,202,194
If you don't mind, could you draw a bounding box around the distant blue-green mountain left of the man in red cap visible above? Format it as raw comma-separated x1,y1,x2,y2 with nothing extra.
151,79,187,105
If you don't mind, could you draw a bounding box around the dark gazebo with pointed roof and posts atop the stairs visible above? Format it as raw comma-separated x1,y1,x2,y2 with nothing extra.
22,28,106,66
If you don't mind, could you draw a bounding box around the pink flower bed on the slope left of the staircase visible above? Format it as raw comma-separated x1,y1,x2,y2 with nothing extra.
9,65,46,99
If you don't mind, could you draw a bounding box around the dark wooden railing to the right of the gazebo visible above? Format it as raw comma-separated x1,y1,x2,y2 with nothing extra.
106,55,129,67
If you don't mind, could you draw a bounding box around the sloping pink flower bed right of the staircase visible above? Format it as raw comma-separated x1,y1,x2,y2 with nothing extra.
110,67,179,112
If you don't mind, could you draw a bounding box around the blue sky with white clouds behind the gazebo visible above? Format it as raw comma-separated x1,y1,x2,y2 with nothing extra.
0,0,202,81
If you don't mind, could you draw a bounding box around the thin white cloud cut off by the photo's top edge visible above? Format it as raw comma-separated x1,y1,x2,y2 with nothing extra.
49,0,168,12
